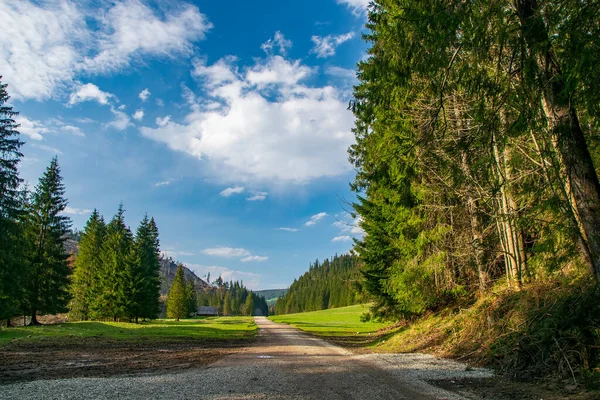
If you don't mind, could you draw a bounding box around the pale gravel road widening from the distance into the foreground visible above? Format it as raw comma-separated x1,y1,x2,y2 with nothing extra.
0,317,491,400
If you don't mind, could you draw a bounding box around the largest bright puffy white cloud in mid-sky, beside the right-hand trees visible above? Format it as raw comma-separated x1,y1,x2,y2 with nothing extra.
140,51,354,184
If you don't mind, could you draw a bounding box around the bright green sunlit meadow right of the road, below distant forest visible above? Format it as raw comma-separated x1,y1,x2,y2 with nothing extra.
269,305,390,344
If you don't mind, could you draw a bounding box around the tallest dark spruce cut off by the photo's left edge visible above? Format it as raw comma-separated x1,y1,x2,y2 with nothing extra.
0,76,24,325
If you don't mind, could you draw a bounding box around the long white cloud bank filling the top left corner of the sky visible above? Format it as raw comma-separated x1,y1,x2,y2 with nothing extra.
0,0,212,100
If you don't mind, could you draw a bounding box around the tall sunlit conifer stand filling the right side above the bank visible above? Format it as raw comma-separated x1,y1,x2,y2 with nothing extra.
349,0,600,318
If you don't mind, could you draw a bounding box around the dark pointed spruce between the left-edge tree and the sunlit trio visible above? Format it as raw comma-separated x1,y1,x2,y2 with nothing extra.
26,157,71,325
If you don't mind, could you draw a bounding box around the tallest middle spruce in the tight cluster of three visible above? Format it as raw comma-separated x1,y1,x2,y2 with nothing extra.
92,204,134,321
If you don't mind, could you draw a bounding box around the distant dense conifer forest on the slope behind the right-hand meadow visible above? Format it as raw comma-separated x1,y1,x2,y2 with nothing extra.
275,254,361,314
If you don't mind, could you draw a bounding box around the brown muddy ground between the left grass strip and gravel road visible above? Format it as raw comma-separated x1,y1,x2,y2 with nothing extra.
0,340,252,385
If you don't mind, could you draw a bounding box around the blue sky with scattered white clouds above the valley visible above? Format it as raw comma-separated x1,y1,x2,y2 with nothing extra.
0,0,368,289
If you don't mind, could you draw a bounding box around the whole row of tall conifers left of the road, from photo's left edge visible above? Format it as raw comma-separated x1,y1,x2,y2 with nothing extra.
0,77,159,326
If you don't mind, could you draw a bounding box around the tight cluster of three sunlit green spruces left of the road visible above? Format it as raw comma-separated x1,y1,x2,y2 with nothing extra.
69,205,160,323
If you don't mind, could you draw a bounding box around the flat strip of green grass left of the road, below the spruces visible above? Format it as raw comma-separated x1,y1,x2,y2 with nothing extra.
0,317,257,346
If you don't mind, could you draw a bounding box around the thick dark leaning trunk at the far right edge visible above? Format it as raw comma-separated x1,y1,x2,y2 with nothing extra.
515,0,600,281
